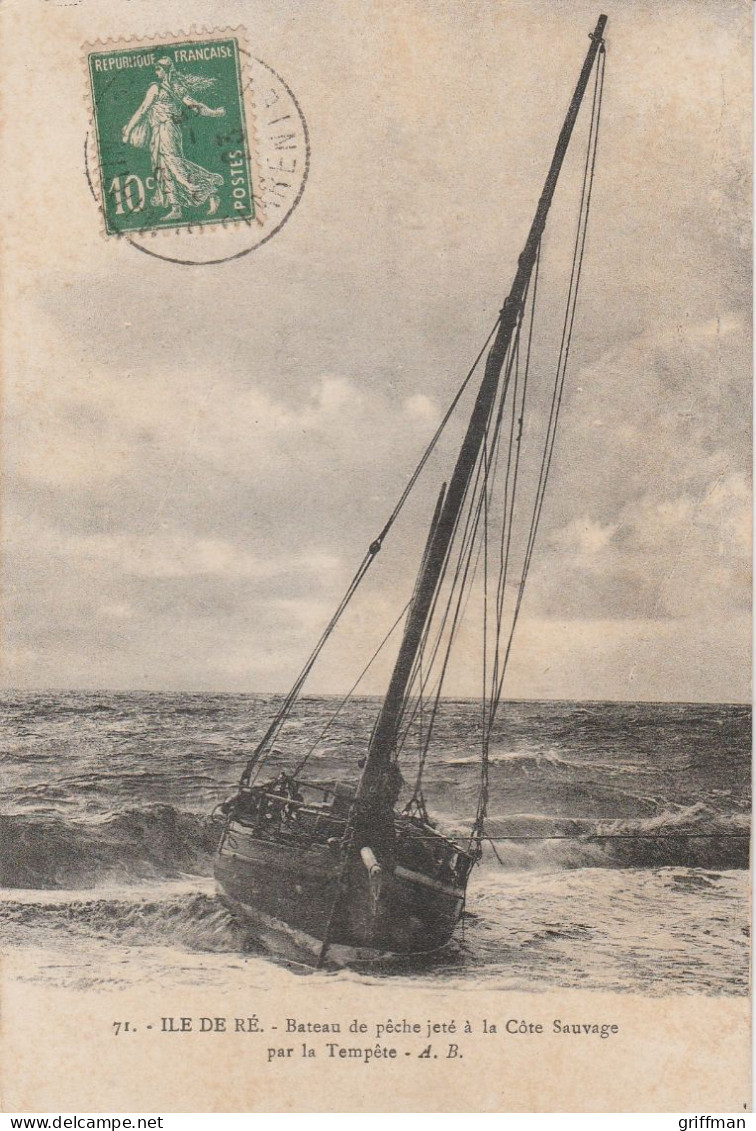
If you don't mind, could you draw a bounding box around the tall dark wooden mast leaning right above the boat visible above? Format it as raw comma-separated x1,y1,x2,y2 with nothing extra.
358,16,607,801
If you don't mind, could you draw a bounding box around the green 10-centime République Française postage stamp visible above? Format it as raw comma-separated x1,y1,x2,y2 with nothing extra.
87,36,257,235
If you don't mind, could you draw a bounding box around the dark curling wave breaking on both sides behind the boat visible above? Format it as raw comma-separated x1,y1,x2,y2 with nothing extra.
0,804,749,889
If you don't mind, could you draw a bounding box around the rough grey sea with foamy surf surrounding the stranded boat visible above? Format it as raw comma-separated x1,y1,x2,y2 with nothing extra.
0,691,750,995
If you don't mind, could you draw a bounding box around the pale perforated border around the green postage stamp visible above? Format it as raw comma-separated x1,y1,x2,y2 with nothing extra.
80,24,265,241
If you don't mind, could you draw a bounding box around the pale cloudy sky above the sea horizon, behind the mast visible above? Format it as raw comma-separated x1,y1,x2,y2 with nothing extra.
2,0,751,700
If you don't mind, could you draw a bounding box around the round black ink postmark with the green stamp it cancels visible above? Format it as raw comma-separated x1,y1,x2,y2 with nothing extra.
85,38,310,266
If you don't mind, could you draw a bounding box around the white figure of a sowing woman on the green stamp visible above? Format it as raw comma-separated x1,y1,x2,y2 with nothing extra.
123,58,225,219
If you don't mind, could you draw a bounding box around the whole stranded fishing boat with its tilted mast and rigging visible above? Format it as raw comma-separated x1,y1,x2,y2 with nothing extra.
215,16,607,966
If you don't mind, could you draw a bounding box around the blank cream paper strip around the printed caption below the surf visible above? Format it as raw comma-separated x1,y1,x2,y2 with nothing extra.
0,0,749,1112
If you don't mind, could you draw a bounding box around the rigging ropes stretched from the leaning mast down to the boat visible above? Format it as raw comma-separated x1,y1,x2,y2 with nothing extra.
242,44,605,823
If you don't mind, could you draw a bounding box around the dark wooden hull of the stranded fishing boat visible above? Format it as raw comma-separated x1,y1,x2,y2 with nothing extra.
215,820,466,962
